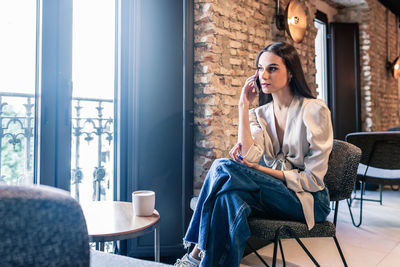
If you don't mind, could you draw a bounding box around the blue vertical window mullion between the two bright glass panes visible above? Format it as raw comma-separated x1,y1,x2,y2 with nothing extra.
38,0,72,190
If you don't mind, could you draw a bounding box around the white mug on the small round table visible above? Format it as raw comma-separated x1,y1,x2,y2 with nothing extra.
132,190,156,216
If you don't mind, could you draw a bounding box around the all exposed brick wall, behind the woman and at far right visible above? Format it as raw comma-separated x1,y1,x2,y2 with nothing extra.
194,0,398,194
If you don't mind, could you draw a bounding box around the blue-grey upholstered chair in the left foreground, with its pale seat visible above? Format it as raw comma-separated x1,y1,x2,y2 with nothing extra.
0,185,170,267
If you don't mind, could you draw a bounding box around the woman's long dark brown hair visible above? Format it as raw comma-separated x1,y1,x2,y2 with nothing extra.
255,42,315,106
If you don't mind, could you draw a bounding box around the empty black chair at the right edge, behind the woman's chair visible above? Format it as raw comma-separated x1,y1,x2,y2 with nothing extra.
346,131,400,227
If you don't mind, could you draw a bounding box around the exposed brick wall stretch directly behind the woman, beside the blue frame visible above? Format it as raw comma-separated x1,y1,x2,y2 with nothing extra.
194,0,316,193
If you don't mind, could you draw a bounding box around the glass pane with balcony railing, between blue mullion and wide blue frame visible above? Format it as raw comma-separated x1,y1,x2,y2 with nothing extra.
71,0,117,202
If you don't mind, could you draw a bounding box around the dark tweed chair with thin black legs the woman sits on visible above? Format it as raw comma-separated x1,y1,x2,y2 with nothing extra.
248,140,361,266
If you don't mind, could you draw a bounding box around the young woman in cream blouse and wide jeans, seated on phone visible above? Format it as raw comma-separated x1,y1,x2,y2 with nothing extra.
175,42,333,267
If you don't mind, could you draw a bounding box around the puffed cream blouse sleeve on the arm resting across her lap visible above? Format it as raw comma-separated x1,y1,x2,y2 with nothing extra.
284,101,333,192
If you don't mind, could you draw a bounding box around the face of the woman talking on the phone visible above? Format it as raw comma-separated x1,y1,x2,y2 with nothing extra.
257,52,292,94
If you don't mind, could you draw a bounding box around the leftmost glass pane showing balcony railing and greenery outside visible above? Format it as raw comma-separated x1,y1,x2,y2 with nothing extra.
0,0,39,185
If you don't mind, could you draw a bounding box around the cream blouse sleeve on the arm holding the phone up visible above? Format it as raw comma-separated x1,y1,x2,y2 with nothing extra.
244,109,264,163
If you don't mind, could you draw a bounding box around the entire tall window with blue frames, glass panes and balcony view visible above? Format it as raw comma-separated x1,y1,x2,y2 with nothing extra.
0,0,194,256
